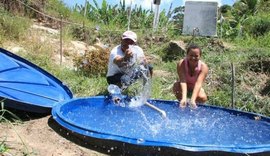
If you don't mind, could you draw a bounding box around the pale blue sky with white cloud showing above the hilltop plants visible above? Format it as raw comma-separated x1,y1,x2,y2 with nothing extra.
62,0,236,11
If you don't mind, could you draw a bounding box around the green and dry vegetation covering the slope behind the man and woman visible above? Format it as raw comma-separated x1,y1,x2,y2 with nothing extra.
0,0,270,154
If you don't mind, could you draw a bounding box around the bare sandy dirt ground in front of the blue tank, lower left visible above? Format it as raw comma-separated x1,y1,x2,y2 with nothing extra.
0,109,111,156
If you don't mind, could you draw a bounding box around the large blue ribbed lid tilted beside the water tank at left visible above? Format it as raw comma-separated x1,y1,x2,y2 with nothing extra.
0,48,73,113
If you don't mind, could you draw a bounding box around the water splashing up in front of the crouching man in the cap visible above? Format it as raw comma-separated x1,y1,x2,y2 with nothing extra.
108,46,151,107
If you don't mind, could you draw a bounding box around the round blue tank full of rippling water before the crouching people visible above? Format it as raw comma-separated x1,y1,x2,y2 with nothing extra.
52,96,270,153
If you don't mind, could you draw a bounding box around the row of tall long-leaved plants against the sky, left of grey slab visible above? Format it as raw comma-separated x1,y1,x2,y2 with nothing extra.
73,0,171,29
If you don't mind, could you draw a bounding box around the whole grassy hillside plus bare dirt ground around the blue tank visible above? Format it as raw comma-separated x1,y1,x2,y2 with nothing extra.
0,0,270,156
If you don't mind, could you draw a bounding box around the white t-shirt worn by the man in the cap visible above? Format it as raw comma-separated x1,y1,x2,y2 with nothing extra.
107,45,144,77
